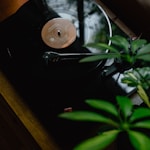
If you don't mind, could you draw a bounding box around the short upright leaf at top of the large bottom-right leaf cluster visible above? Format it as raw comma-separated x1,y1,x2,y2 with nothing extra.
116,96,133,118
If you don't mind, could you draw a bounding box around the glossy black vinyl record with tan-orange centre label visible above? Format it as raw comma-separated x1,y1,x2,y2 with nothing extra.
38,0,112,79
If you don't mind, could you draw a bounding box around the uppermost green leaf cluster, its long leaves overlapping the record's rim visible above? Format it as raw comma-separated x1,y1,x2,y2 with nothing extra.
80,35,150,66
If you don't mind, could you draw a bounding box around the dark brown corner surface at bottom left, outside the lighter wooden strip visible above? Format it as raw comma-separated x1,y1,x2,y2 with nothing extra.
0,94,41,150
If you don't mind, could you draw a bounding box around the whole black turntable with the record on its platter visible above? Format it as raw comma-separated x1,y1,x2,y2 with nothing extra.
0,0,127,150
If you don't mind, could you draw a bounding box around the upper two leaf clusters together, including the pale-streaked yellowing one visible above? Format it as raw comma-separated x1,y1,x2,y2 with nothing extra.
80,35,150,107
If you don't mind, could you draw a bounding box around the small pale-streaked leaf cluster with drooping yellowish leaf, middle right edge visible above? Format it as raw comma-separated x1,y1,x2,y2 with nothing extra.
121,67,150,107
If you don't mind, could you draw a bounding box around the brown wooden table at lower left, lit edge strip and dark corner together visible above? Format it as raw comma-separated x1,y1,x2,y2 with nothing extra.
0,72,59,150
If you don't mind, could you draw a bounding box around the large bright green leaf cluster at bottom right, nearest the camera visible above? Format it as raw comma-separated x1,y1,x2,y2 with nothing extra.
59,96,150,150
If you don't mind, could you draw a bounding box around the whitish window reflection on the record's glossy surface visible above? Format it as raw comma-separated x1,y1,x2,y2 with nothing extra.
47,0,112,52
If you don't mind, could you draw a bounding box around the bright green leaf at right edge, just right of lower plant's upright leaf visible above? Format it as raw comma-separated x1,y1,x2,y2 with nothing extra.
130,107,150,121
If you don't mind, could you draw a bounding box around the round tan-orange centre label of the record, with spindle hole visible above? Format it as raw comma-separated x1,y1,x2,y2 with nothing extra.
41,18,76,49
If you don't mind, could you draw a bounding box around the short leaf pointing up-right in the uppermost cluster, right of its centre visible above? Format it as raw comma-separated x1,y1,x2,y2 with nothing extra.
131,39,147,53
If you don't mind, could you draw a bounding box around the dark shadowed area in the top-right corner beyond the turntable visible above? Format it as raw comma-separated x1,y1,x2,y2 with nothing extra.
100,0,150,40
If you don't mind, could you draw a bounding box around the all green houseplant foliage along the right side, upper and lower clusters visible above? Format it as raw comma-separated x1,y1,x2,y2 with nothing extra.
59,35,150,150
